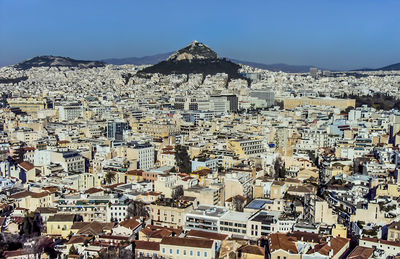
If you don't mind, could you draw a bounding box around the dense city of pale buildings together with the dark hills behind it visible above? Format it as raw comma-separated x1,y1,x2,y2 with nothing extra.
0,41,400,259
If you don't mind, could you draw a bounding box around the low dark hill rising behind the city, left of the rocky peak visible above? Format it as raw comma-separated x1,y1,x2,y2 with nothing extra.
14,56,105,70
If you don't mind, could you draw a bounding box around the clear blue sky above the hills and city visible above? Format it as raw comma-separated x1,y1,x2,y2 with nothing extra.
0,0,400,69
